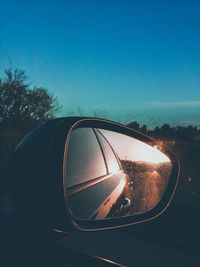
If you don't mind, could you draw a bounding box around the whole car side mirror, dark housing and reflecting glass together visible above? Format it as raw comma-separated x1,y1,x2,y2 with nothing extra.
10,117,179,230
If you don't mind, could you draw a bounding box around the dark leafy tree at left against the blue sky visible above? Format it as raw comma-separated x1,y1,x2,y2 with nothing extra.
0,69,61,128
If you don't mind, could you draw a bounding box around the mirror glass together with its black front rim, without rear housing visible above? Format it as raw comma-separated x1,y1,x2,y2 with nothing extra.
63,119,178,229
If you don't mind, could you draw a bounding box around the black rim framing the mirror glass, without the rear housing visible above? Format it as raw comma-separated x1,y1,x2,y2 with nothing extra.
63,118,179,230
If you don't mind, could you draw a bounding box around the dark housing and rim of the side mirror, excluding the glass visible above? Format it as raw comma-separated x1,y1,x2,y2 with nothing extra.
9,117,179,231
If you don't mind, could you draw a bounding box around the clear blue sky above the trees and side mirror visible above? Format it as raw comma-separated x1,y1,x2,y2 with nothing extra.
0,0,200,127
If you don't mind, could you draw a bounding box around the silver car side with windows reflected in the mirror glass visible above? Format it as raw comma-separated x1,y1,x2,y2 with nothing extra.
65,128,127,219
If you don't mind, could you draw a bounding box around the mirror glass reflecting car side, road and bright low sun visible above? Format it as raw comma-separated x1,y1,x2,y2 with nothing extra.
65,128,172,220
